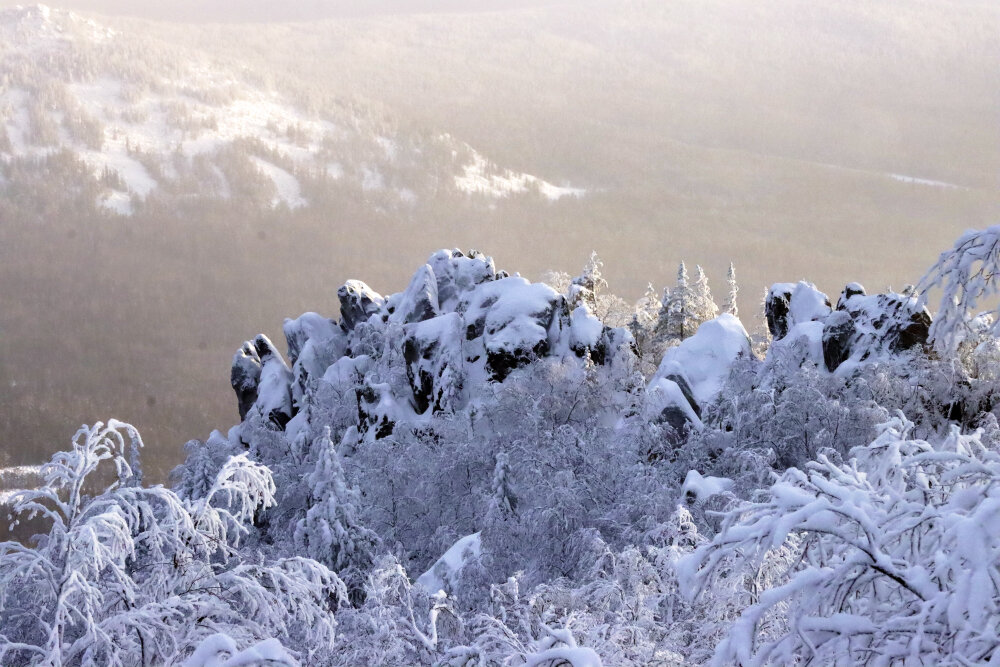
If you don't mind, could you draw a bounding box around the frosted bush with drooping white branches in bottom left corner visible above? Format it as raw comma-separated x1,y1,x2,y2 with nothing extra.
0,420,346,665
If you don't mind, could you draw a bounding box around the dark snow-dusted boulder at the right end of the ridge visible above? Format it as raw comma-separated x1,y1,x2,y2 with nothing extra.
823,283,931,371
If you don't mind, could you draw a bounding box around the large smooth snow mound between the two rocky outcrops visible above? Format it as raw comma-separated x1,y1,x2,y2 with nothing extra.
654,313,752,405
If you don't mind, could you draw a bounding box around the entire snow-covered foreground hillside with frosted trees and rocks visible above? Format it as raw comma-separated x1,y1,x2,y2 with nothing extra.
0,227,1000,667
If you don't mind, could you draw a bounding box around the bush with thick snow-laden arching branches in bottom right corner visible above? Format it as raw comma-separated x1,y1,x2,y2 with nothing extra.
681,416,1000,665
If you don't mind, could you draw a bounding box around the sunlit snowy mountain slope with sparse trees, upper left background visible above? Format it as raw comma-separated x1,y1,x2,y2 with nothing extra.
0,5,582,214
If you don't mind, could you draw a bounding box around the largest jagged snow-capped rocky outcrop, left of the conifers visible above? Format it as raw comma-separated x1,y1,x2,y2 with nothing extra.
233,250,634,437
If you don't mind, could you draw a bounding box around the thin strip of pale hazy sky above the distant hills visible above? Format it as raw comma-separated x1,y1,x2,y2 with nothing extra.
0,0,559,22
